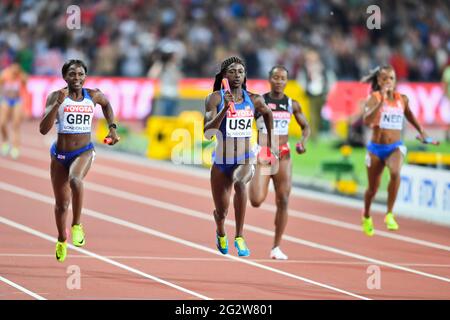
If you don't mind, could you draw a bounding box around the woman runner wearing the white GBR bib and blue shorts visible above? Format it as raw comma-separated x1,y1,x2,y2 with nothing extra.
39,60,120,262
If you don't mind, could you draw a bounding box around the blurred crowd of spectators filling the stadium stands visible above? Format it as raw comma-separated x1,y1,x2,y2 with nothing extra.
0,0,450,81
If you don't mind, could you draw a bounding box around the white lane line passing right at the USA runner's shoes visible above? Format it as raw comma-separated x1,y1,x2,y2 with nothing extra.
0,181,370,300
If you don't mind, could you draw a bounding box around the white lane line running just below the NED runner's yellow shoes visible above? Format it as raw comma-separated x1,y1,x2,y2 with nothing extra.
15,151,450,252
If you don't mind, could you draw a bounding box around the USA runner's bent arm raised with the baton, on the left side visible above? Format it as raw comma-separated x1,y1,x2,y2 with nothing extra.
203,91,233,139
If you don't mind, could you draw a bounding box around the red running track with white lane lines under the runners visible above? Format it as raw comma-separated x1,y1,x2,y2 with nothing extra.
0,122,450,300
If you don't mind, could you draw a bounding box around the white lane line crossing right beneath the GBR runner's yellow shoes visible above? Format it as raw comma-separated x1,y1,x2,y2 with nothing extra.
0,216,211,300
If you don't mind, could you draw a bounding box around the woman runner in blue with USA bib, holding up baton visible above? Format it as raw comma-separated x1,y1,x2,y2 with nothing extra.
204,57,278,257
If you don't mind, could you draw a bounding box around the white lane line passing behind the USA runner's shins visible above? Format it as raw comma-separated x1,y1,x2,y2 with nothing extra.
0,161,450,282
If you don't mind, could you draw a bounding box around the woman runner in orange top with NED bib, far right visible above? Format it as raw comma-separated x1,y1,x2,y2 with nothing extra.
362,66,430,236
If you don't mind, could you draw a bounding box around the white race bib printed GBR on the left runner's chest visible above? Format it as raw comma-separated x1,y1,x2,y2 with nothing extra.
63,105,94,133
